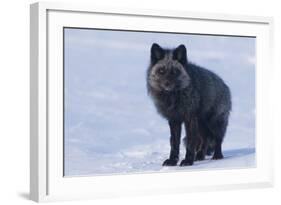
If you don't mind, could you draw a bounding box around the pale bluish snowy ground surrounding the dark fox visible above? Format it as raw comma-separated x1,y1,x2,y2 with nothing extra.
65,29,255,176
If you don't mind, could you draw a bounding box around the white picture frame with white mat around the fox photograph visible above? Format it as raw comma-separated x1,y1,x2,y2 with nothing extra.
30,2,274,202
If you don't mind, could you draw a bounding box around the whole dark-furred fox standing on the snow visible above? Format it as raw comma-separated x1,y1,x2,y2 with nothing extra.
146,43,232,166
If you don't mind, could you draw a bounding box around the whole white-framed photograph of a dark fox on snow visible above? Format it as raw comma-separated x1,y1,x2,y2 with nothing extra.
30,3,273,201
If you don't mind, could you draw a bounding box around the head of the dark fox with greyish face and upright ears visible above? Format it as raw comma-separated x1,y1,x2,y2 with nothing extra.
147,43,190,92
